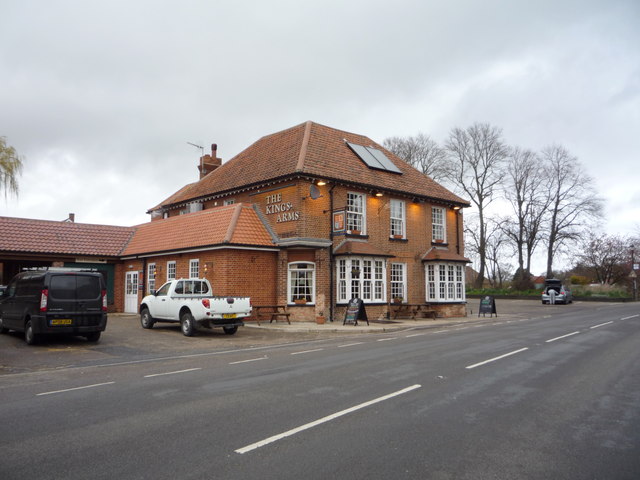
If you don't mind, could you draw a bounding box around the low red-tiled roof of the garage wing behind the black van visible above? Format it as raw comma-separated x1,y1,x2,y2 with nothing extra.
0,217,135,257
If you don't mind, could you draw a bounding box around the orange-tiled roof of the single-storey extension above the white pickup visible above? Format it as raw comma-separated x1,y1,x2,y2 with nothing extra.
122,203,275,256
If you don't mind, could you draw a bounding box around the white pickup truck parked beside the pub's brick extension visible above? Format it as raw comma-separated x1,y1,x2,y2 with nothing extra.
140,278,251,337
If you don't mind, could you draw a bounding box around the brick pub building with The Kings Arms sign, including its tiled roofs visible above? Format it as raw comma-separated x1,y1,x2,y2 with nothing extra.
0,122,469,321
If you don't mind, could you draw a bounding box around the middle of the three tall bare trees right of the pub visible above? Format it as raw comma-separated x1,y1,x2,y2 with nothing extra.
501,147,549,290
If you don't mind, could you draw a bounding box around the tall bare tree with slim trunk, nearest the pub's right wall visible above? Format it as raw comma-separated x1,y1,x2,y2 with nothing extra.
446,123,508,288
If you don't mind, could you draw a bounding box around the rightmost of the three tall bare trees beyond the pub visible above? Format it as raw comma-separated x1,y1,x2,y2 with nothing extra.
541,145,602,277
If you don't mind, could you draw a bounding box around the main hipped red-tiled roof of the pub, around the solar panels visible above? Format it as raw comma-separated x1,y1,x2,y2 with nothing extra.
152,122,469,207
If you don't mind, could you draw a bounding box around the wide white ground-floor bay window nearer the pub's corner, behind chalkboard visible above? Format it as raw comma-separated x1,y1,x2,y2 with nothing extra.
336,257,387,303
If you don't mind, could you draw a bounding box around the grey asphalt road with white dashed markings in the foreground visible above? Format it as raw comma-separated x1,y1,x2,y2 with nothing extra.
0,303,640,479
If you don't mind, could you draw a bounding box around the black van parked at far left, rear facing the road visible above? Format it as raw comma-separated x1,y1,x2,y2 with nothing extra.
0,268,107,345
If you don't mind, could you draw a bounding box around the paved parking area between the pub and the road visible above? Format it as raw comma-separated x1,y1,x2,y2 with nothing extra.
0,299,571,375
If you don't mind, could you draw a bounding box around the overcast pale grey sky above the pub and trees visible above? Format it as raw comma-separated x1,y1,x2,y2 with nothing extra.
0,0,640,270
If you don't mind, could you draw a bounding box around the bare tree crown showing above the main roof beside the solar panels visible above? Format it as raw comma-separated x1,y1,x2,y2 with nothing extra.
382,133,446,182
